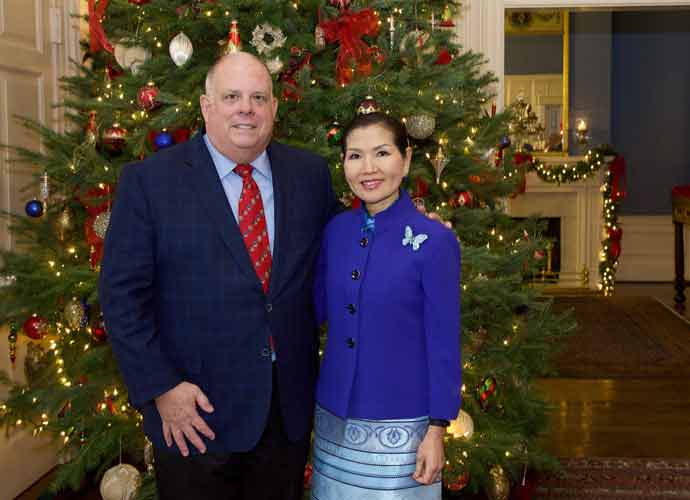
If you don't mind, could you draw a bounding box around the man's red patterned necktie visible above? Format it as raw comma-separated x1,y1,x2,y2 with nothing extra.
234,165,272,293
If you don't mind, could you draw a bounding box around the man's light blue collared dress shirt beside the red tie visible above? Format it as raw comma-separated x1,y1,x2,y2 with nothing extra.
204,134,275,255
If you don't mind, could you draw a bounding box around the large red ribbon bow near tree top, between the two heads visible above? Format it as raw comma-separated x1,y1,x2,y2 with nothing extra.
319,8,379,85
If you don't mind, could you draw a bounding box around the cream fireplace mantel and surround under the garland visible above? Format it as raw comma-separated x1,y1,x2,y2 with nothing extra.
507,156,606,289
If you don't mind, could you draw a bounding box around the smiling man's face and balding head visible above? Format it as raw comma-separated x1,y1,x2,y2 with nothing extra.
201,54,278,163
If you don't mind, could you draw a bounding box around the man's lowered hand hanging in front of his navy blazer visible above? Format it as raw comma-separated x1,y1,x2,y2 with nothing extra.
156,382,216,457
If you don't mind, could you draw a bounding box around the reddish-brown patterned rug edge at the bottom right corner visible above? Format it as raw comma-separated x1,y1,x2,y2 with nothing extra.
532,458,690,500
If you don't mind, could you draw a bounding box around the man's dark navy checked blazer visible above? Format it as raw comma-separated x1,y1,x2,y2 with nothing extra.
99,134,338,453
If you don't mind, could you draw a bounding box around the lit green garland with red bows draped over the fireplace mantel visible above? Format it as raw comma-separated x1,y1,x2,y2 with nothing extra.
515,146,626,296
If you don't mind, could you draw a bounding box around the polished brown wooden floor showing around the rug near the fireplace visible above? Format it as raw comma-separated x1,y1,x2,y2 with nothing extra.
539,283,690,458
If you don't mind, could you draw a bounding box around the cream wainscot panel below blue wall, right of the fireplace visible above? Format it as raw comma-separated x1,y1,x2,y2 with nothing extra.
616,214,690,283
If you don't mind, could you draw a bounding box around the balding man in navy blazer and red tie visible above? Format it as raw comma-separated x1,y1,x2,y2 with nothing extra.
99,53,338,500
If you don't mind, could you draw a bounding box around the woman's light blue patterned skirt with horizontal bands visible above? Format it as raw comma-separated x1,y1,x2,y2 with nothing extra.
311,406,441,500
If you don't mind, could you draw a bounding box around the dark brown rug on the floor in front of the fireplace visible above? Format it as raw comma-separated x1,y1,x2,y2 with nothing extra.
554,296,690,376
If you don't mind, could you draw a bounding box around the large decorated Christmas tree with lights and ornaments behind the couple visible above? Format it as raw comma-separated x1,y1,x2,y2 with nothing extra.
0,0,572,500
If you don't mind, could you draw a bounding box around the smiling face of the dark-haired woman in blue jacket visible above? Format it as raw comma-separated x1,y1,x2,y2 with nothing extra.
343,124,412,215
